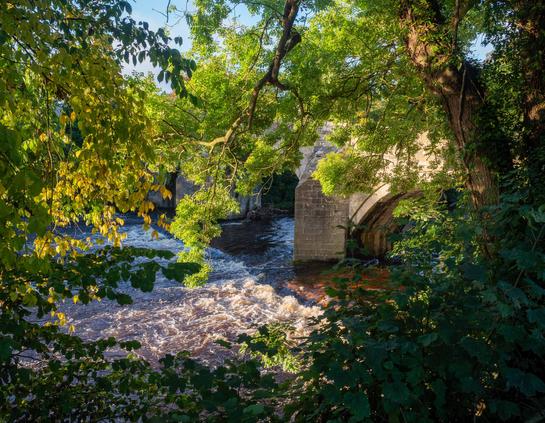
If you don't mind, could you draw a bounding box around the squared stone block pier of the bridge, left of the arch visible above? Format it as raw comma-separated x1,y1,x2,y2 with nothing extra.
294,178,349,261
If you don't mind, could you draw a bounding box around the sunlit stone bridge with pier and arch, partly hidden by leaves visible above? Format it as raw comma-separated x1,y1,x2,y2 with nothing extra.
294,132,437,261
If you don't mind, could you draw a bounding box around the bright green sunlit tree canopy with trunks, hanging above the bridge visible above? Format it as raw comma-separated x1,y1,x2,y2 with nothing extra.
149,1,543,262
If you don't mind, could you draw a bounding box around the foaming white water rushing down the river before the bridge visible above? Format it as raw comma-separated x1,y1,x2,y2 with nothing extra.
63,219,320,364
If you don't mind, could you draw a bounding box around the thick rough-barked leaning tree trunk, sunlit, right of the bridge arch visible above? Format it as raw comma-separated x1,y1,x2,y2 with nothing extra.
401,1,499,209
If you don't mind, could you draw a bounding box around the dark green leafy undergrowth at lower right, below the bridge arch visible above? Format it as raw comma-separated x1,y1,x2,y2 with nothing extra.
289,183,545,422
